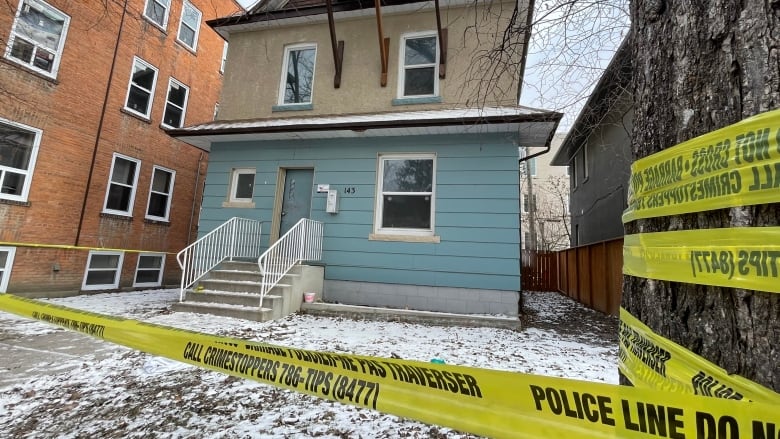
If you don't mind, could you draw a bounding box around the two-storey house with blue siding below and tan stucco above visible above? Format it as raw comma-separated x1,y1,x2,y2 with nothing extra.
169,0,561,315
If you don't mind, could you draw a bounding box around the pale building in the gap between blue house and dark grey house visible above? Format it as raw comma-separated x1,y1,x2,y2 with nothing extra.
520,134,571,251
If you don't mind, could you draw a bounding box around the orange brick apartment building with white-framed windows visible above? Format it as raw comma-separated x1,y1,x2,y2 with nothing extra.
0,0,240,295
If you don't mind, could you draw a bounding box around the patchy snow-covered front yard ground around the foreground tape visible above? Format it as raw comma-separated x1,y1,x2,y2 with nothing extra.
0,290,618,438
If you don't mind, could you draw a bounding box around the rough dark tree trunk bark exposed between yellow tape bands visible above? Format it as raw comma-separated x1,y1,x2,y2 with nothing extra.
622,0,780,391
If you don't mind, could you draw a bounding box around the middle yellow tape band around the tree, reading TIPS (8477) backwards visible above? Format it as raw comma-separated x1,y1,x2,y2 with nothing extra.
623,227,780,293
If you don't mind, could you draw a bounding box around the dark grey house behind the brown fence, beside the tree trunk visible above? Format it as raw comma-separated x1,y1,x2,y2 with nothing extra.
552,41,634,247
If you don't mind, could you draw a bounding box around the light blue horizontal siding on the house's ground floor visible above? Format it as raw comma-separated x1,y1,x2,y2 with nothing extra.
200,135,520,291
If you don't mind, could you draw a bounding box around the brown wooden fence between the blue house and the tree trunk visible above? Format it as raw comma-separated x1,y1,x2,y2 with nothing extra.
521,238,623,315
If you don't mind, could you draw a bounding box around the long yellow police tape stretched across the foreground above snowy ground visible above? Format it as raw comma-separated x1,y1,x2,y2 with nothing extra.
0,294,780,439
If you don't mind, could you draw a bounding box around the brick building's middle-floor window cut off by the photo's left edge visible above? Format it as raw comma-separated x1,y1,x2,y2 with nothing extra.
0,119,42,201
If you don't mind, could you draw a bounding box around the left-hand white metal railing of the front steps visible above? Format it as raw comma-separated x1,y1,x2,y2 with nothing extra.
176,217,263,301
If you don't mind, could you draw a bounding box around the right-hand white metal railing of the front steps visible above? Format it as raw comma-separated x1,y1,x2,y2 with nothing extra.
257,218,325,307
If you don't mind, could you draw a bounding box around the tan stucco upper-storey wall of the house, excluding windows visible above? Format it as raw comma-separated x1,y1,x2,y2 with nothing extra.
219,2,522,120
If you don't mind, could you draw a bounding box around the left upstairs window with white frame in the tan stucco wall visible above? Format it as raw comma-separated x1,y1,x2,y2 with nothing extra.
279,44,317,105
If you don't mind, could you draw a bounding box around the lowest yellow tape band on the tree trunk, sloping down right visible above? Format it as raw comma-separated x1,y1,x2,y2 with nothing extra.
618,308,780,410
